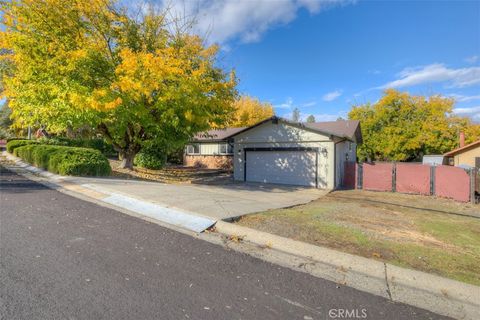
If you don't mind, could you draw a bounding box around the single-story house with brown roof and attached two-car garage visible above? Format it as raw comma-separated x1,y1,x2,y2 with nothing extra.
185,116,362,189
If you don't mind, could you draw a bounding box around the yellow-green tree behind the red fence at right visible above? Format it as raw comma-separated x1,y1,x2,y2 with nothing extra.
348,89,480,161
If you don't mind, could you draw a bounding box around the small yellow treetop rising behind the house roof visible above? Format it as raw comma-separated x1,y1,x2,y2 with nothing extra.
228,96,274,127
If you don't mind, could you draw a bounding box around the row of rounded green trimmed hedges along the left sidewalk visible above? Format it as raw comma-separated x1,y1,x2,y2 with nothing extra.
13,144,112,176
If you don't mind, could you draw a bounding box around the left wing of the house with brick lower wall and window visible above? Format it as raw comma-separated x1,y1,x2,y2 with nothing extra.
183,128,245,170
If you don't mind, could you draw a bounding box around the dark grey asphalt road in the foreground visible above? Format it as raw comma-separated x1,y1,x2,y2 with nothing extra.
0,169,450,320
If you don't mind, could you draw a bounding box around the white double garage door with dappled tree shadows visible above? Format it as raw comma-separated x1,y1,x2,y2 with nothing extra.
245,150,316,187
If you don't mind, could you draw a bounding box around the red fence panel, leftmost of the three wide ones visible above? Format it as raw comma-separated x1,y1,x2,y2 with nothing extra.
363,162,393,191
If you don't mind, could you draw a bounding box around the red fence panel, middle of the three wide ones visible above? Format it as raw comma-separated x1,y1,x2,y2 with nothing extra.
395,162,430,195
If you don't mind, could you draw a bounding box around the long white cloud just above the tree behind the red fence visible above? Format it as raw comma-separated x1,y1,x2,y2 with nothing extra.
377,63,480,89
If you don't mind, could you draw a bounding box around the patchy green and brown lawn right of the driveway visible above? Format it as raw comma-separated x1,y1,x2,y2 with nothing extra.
237,191,480,285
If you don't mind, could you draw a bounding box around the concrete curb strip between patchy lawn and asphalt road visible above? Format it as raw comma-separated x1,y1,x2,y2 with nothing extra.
215,221,480,320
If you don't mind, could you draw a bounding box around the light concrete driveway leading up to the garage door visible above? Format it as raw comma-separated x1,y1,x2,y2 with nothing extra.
74,178,327,220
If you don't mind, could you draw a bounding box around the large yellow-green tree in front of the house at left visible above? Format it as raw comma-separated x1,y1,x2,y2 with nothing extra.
0,0,236,168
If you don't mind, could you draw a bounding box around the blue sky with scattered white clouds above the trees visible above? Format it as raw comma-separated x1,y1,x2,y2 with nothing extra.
156,0,480,122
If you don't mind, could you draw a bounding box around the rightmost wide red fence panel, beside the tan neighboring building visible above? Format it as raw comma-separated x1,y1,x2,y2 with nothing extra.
435,166,470,202
